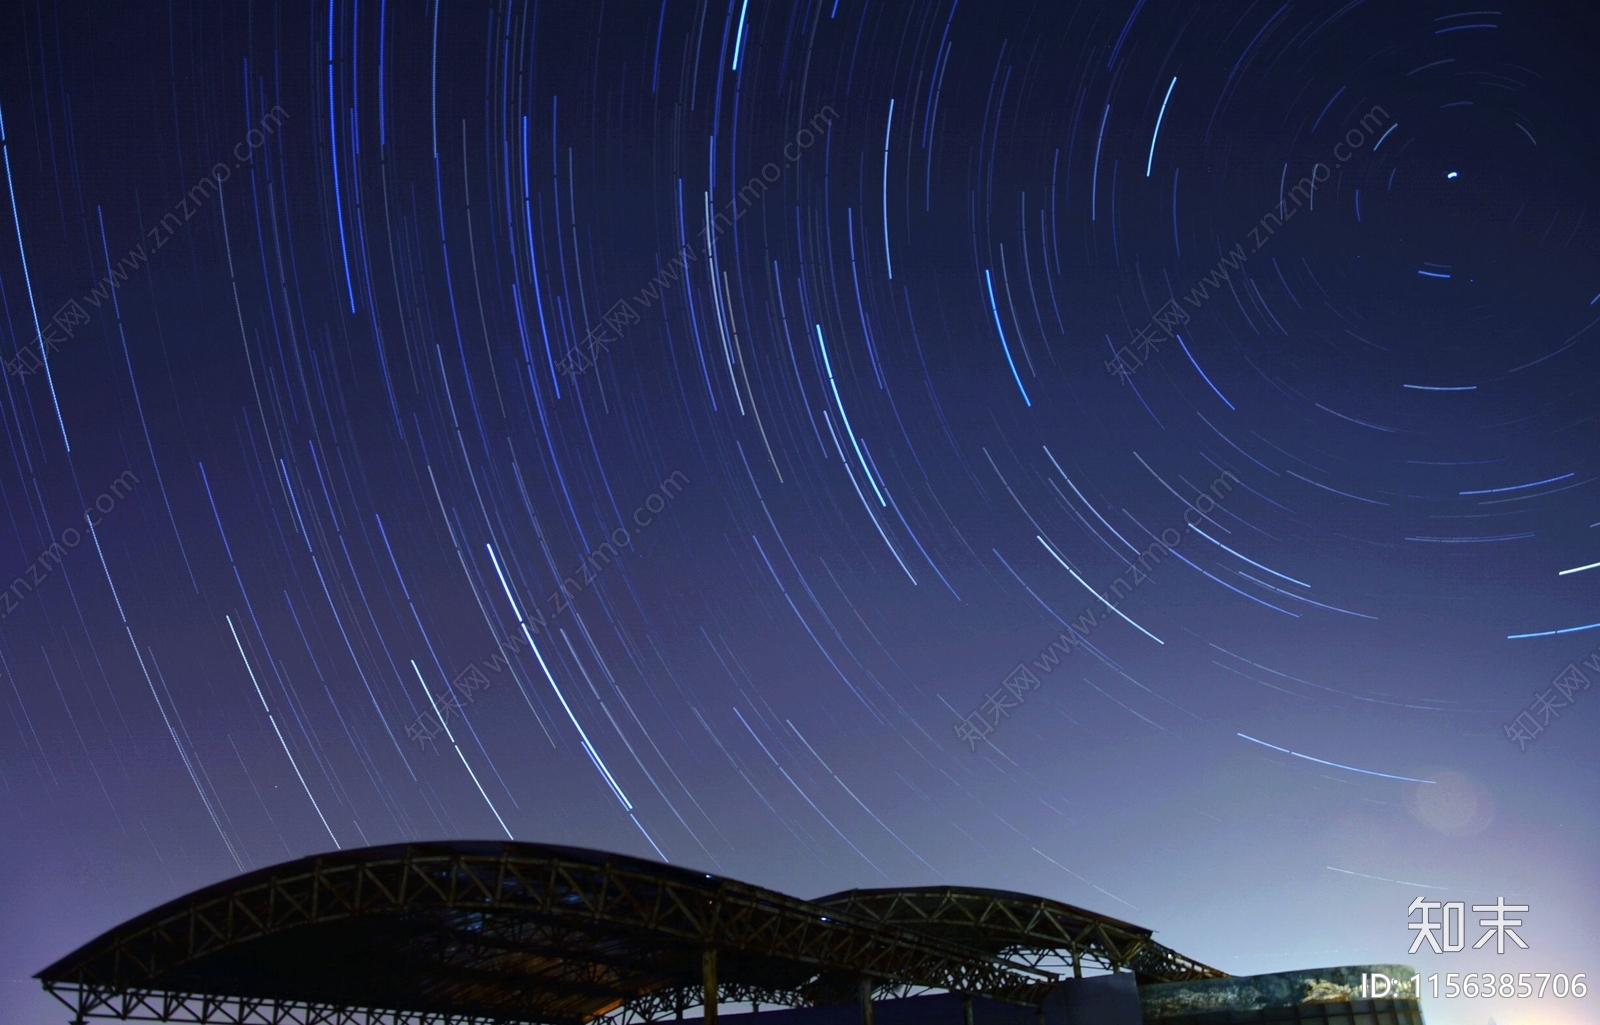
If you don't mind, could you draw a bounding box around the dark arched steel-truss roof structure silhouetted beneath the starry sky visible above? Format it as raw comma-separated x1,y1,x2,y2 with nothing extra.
38,843,1224,1025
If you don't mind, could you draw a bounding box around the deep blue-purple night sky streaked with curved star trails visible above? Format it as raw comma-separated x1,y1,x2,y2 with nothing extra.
0,0,1600,1025
